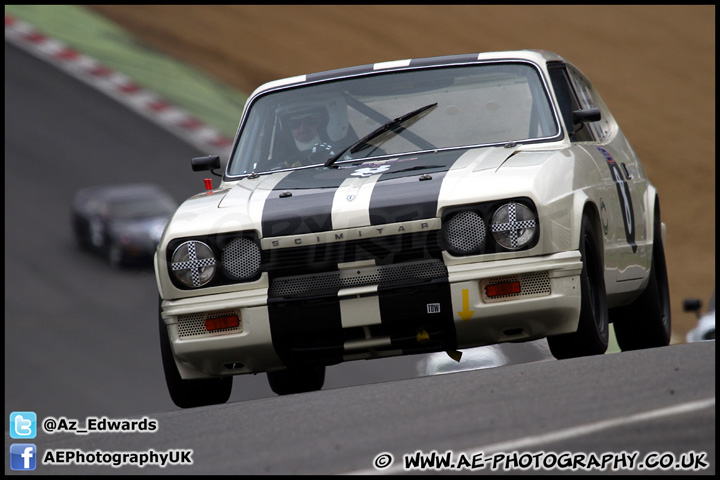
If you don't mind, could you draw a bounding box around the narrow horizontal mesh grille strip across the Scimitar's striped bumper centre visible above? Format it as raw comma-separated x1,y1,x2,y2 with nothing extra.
270,259,448,298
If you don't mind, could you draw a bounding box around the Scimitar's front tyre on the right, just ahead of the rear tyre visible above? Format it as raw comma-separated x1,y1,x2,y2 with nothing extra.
547,215,610,359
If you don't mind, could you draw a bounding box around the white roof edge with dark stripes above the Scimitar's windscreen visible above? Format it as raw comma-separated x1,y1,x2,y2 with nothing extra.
249,50,565,98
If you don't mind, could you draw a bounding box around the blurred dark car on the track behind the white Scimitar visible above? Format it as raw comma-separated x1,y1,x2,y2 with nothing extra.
72,184,178,266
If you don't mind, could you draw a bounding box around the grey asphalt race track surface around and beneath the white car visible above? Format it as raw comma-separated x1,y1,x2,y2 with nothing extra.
5,36,715,474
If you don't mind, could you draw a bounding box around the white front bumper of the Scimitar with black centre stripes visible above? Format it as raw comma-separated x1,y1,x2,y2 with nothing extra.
161,251,582,379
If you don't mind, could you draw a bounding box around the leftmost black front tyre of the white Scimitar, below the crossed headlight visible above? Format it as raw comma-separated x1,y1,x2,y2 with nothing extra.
159,302,233,408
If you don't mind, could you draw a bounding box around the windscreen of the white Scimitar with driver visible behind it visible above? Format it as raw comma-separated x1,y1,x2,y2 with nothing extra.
227,62,560,176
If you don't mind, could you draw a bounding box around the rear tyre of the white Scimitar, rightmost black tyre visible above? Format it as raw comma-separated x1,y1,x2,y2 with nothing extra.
610,204,672,351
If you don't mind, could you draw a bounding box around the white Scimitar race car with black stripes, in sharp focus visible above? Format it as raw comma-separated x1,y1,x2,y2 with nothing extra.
155,50,670,407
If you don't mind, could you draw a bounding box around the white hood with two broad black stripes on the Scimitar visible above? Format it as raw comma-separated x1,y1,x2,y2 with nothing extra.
167,143,557,238
